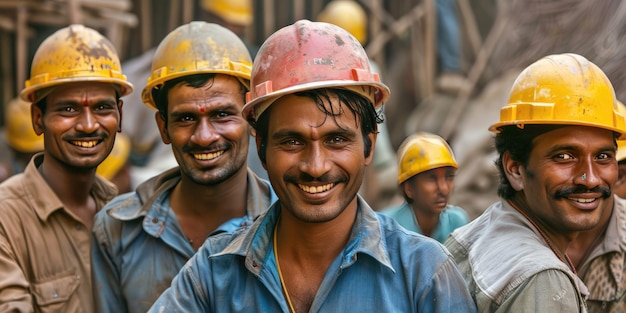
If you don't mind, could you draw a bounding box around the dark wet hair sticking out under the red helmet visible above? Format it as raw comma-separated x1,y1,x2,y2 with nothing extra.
251,88,383,163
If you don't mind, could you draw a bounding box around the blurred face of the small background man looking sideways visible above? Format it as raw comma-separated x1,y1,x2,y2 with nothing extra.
404,166,456,215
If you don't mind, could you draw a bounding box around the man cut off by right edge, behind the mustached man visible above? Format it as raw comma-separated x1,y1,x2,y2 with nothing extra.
567,101,626,312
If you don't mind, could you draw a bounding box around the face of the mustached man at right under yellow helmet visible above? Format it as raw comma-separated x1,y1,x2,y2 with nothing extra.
514,126,618,233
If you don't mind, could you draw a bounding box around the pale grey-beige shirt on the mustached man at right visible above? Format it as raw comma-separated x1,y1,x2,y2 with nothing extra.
445,200,588,313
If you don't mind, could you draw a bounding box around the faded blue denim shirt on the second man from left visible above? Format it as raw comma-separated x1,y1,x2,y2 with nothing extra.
92,168,276,313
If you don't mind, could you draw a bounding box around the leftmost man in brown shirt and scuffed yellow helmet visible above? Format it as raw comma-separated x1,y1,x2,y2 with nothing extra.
0,24,133,312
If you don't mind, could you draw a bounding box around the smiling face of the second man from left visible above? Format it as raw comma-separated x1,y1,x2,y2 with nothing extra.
156,75,249,185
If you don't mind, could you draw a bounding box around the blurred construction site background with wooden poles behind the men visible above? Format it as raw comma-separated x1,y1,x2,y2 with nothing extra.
0,0,626,217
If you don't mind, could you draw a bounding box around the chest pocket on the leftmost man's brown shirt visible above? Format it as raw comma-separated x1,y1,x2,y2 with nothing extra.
31,273,80,312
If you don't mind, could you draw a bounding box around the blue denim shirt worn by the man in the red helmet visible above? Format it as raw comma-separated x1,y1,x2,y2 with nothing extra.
149,198,476,313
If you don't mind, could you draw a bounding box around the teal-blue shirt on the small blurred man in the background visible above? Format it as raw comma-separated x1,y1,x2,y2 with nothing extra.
381,201,469,243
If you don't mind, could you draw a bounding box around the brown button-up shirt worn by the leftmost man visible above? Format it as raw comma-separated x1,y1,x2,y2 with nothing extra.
0,154,117,313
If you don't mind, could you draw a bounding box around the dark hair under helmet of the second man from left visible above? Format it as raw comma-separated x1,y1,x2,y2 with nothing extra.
151,73,246,125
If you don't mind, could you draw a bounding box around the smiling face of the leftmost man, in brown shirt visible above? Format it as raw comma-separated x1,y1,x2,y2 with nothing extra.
32,82,122,170
